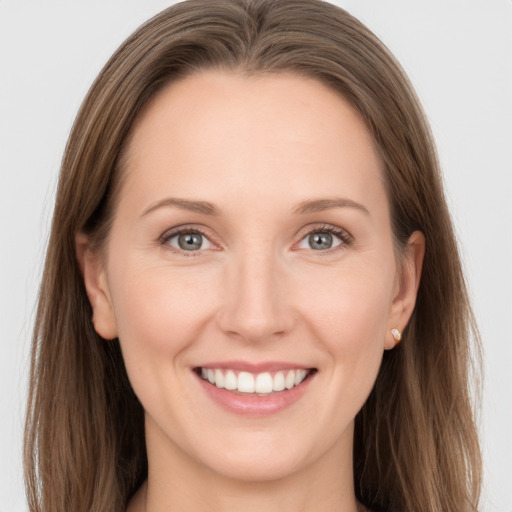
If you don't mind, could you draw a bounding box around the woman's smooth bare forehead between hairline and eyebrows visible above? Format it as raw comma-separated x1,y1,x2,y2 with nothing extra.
119,71,384,216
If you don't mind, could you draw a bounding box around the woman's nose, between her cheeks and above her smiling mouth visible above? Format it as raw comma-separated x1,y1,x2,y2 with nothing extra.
217,248,295,342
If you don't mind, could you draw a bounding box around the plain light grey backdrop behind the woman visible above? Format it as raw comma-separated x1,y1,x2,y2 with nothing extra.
0,0,512,512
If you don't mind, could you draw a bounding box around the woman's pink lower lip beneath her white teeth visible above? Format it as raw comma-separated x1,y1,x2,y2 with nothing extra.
195,374,314,416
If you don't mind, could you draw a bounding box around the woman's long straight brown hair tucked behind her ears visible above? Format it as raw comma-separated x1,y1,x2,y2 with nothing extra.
25,0,481,512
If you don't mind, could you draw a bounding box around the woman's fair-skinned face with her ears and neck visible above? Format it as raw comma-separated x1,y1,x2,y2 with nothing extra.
77,71,424,512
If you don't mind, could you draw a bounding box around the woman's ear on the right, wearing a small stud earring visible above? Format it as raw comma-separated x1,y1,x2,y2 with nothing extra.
384,231,425,350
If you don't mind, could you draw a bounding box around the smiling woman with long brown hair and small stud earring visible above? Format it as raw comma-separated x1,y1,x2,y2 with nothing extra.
26,0,480,512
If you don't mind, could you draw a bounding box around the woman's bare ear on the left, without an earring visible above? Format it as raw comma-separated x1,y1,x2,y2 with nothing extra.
75,233,117,340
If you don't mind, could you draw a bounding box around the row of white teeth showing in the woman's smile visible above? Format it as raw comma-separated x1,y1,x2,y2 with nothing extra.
194,367,316,396
